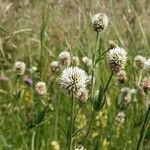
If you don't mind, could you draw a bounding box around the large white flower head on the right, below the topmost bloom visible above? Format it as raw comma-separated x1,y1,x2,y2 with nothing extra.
108,47,127,72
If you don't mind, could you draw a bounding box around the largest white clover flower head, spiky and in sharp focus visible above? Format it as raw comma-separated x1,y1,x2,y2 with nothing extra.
59,66,88,92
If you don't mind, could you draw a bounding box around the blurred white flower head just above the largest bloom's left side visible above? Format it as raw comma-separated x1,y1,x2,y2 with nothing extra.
59,51,71,66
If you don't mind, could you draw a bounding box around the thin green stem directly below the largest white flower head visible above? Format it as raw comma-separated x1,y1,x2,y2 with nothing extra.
68,92,74,150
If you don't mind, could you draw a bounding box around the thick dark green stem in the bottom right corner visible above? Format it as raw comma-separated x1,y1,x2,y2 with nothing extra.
136,105,150,150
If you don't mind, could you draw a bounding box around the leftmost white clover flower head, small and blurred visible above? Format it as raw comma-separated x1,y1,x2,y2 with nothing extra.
14,61,26,75
